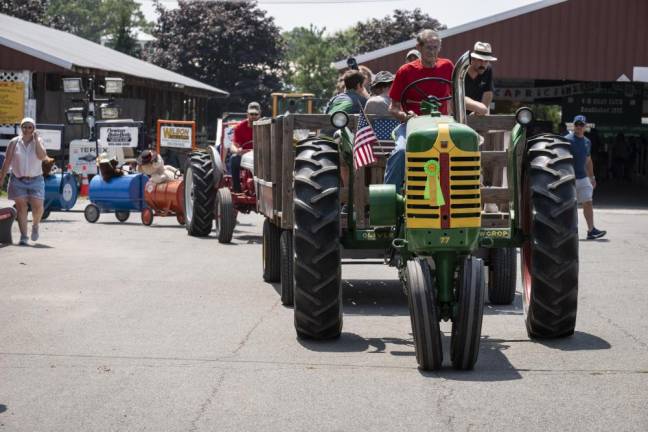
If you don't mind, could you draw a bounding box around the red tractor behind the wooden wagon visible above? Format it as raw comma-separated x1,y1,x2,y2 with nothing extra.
184,114,256,243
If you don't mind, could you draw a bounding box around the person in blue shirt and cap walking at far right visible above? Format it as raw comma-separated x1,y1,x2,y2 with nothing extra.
565,115,607,240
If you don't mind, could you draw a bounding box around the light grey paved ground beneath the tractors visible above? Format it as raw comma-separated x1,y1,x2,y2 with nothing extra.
0,201,648,432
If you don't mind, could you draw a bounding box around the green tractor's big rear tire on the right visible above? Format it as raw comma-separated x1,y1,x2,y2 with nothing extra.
521,135,578,338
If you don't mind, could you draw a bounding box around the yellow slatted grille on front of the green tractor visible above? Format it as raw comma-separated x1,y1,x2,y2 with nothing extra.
405,124,481,229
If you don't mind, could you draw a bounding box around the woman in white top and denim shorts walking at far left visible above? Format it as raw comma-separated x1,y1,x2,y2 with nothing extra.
0,117,47,245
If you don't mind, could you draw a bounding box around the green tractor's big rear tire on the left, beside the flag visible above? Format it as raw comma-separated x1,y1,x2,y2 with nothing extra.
293,139,342,339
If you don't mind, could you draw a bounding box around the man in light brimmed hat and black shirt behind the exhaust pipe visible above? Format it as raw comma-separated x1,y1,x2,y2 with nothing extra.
464,42,497,114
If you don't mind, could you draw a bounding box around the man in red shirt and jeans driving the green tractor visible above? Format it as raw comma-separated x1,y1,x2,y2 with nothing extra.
385,30,485,191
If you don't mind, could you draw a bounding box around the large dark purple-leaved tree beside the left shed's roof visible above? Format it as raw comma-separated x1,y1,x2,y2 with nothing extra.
148,0,283,110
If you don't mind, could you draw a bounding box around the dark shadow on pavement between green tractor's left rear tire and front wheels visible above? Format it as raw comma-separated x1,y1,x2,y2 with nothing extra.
342,279,409,316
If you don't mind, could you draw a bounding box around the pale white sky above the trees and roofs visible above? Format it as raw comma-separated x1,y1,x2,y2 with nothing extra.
139,0,538,33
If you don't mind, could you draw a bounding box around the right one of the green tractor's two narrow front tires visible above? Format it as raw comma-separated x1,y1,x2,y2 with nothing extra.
450,256,485,370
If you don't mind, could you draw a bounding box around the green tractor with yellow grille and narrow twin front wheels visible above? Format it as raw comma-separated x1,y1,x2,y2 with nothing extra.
255,49,578,370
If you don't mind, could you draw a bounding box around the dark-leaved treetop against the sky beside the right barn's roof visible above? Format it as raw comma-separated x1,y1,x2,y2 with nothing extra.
353,8,446,53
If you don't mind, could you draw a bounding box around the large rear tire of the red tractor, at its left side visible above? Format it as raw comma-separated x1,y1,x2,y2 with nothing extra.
184,152,216,237
